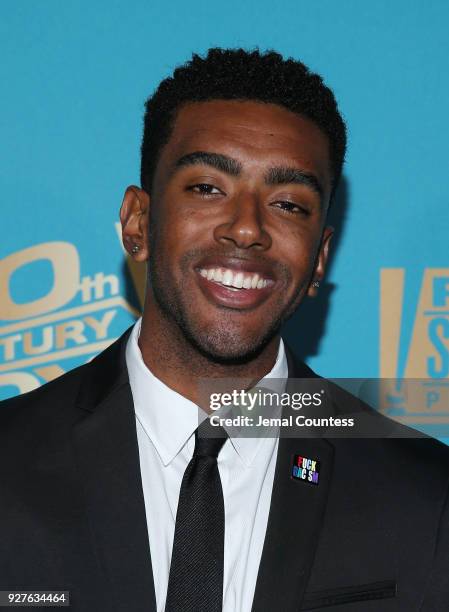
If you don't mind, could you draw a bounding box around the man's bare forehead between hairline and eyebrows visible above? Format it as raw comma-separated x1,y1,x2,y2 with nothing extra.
160,100,331,188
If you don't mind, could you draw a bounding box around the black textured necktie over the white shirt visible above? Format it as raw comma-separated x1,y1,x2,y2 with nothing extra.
165,419,226,612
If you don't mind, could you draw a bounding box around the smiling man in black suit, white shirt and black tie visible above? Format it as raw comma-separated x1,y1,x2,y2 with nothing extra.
0,49,449,612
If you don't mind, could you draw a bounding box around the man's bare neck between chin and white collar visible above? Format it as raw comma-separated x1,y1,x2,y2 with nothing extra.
139,301,280,405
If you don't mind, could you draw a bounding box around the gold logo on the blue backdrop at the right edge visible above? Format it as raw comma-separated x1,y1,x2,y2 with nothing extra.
380,268,449,436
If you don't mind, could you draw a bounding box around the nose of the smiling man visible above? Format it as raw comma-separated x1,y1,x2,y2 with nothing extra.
214,193,272,251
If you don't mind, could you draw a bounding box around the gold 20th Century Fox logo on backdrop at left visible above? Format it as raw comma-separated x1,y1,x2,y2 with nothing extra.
0,227,138,399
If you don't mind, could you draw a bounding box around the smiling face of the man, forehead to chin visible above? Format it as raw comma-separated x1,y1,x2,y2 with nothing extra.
145,100,332,361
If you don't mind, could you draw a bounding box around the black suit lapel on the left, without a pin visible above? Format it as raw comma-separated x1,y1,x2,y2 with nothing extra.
72,333,156,612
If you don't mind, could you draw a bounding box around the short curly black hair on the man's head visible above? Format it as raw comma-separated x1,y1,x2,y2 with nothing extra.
140,48,346,201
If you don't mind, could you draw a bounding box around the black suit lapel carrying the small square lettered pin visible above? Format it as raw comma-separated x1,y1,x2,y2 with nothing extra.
252,349,334,612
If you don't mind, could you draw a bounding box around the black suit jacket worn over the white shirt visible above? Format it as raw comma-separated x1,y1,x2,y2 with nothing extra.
0,334,449,612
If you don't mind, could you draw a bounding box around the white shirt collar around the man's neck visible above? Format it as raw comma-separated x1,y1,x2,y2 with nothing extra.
126,319,288,466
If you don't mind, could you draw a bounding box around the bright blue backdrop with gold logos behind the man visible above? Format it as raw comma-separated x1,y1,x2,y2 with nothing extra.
0,0,449,436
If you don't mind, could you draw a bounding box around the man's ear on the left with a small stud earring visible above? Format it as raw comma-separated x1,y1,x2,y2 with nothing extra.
120,185,150,261
